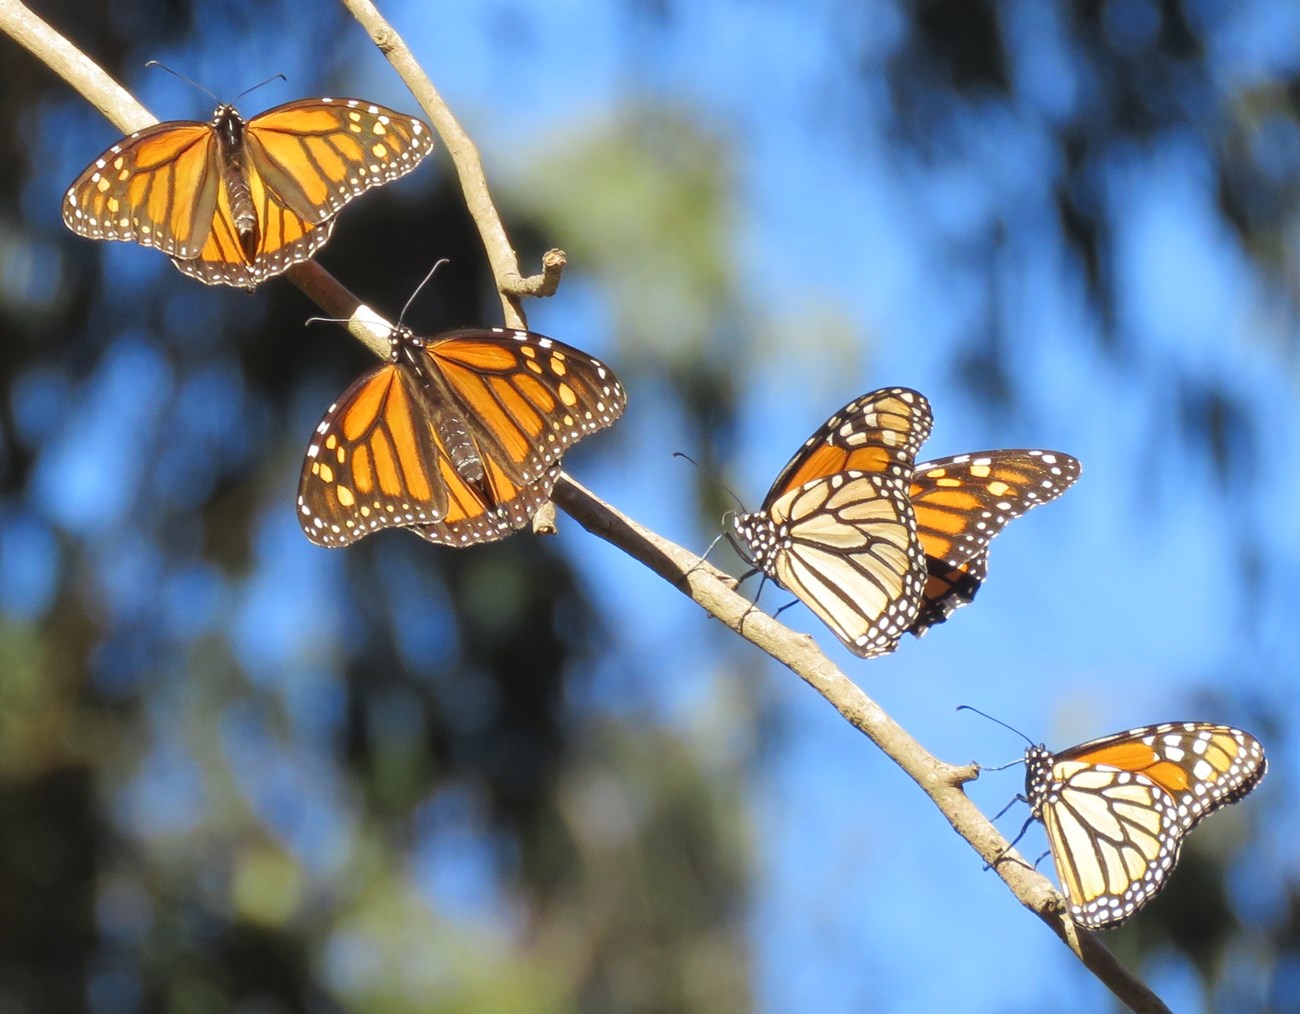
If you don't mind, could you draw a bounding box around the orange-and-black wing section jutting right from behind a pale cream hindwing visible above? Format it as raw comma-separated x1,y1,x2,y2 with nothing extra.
907,450,1083,637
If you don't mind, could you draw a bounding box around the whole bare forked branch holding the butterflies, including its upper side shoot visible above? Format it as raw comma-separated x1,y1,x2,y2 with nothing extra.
0,0,1167,1014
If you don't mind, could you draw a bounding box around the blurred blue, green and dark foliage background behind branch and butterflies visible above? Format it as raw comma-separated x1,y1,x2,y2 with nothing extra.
0,0,1300,1014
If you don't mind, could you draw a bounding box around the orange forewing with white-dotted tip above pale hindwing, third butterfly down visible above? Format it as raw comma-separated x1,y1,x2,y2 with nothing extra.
763,387,933,508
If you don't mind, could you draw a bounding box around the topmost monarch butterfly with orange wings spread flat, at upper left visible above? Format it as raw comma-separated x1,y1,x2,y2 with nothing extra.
64,99,433,289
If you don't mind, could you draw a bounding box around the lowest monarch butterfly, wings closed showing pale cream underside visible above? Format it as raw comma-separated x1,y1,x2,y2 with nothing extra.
1024,722,1268,930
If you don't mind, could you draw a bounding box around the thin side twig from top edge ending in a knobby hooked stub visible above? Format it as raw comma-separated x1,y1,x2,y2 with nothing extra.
342,0,566,328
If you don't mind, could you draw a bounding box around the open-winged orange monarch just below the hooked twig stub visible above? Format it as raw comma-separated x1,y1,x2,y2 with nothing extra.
298,325,627,546
